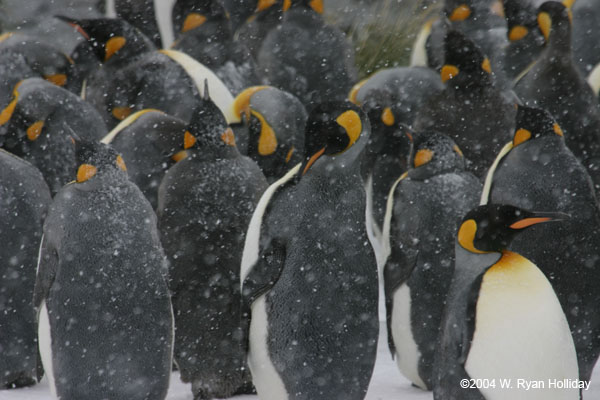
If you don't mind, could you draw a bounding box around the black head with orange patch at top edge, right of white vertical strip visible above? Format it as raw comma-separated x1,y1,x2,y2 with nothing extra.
173,0,229,33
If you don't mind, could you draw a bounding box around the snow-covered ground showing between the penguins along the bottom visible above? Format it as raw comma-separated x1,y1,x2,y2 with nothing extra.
0,324,600,400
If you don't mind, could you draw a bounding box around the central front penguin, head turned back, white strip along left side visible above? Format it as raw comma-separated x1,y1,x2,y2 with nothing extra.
241,102,379,400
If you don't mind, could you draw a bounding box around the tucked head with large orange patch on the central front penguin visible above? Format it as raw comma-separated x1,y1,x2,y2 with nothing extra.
300,101,371,175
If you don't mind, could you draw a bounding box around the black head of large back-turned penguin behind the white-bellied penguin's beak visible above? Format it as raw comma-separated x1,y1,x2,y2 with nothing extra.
513,106,564,147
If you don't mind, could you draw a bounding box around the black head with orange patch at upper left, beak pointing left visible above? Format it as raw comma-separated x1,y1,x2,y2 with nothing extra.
57,16,156,65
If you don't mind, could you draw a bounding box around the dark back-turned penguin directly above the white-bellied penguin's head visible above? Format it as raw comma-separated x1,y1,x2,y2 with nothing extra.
414,30,515,178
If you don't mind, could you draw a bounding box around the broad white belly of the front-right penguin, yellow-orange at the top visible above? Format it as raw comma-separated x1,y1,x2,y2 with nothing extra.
465,252,579,400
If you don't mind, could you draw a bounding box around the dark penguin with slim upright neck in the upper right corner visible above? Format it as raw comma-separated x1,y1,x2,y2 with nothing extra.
515,1,600,190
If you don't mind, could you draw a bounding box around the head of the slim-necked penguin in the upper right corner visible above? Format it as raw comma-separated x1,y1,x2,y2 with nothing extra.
537,1,572,50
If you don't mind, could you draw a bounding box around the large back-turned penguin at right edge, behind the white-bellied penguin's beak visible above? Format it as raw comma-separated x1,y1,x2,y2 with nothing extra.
482,106,600,381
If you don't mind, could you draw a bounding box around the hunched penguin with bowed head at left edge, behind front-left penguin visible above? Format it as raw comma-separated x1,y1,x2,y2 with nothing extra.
0,78,106,195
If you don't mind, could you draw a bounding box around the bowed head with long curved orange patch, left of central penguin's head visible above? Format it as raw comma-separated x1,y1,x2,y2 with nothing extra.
233,86,308,175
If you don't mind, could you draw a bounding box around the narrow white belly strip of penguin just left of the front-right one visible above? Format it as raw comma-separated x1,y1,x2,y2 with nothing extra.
391,283,427,390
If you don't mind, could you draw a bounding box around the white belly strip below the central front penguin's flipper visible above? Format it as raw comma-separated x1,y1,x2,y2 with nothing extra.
248,295,288,400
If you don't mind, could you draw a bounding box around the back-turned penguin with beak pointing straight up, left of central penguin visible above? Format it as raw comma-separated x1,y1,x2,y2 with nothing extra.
157,92,267,399
